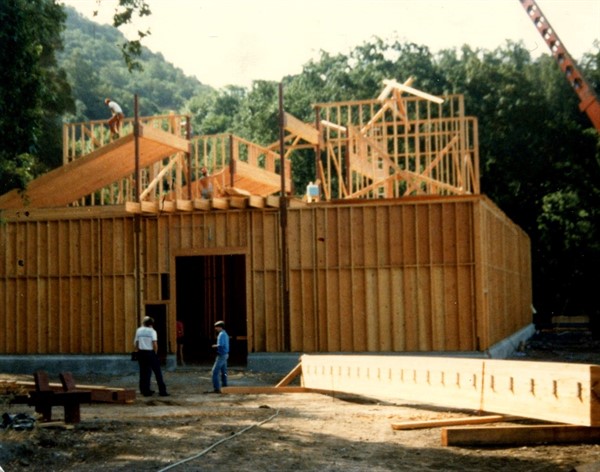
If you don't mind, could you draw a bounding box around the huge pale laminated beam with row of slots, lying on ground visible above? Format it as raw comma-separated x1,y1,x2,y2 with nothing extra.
301,354,600,426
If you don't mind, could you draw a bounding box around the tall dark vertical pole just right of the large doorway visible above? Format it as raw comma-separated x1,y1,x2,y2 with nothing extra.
279,82,290,351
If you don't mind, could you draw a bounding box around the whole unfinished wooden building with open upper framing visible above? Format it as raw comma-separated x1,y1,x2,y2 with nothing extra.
0,84,531,372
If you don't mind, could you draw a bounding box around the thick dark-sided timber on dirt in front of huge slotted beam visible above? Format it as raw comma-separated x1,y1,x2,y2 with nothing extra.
442,425,600,447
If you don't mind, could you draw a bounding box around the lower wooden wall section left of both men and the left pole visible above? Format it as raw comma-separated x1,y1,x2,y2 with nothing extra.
0,211,137,354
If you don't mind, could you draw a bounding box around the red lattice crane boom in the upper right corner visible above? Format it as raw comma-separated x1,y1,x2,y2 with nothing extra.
519,0,600,132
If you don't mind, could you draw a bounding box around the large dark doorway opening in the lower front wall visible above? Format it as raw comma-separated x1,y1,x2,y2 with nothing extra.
175,254,248,366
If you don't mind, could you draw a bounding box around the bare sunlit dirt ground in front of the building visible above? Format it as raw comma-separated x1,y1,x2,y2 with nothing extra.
0,332,600,472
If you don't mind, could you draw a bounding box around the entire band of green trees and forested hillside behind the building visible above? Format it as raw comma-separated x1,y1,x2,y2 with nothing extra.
0,0,600,323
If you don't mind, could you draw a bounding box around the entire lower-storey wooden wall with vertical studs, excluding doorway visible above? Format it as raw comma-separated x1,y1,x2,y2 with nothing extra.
0,196,531,354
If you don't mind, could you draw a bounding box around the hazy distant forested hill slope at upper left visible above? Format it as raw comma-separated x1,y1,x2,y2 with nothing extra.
57,7,210,121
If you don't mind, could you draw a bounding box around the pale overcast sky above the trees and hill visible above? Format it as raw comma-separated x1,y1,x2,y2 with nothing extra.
61,0,600,88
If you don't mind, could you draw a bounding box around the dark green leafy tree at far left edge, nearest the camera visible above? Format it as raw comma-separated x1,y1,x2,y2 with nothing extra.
0,0,73,194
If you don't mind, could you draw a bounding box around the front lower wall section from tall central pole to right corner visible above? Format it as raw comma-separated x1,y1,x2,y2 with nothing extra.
288,199,482,352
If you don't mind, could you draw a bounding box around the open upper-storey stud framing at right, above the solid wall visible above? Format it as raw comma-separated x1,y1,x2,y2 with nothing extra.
316,95,479,200
